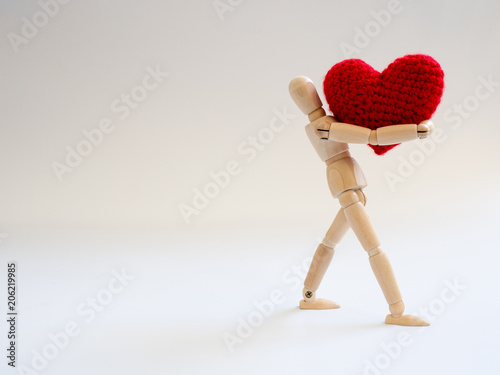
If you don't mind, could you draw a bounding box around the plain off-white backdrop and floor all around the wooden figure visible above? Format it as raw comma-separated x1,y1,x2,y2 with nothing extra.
0,0,500,374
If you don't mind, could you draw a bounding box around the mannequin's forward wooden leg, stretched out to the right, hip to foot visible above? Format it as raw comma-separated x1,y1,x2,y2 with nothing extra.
339,190,429,326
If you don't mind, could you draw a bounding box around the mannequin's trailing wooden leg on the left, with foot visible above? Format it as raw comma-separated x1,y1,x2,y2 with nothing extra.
300,209,349,310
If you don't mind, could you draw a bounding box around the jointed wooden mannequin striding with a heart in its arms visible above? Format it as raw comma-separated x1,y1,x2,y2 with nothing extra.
289,77,434,326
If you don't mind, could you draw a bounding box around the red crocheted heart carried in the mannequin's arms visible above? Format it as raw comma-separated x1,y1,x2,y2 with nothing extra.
323,55,444,155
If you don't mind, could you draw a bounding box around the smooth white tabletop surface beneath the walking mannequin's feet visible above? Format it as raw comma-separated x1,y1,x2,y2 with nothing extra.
2,220,500,375
